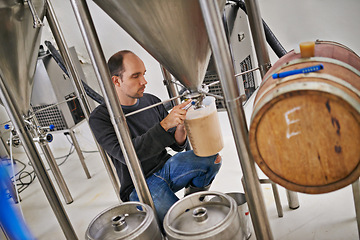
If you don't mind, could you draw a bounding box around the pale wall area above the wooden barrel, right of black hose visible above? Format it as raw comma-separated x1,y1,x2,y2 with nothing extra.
258,0,360,62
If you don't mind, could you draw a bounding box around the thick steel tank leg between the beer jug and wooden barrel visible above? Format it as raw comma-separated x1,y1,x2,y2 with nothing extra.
199,0,273,240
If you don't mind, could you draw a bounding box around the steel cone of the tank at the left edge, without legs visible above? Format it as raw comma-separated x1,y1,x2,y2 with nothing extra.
0,0,45,115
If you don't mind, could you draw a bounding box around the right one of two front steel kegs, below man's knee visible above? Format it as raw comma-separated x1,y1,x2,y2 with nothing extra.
164,192,245,240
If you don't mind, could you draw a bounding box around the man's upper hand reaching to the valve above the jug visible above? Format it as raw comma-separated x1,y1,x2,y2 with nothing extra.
160,99,191,131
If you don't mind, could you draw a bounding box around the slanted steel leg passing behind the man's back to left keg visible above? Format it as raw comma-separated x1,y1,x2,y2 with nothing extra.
46,0,122,202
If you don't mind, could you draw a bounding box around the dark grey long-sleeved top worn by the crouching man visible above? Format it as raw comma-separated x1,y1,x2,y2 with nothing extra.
89,94,187,201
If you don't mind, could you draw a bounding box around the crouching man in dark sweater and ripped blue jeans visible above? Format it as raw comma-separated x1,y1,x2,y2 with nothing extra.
89,50,221,222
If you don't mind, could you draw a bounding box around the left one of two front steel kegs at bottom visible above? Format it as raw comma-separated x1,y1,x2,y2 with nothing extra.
85,202,163,240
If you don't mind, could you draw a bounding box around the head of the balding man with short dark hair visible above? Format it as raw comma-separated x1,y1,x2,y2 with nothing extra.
108,50,147,105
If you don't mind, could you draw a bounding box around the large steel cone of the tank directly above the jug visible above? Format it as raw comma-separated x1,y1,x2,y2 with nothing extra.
94,0,225,92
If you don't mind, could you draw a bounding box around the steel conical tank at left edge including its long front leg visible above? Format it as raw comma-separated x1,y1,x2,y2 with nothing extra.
0,0,77,236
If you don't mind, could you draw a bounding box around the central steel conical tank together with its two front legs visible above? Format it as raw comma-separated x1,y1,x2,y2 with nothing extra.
71,0,272,239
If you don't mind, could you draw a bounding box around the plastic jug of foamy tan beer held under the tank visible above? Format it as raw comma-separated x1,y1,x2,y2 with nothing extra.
185,97,224,157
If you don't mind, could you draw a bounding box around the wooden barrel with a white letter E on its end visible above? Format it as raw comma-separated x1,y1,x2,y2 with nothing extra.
249,41,360,193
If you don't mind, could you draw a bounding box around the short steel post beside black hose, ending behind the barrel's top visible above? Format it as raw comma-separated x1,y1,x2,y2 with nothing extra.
245,0,271,77
